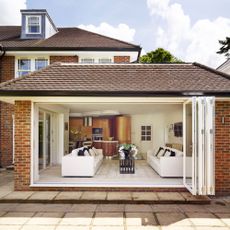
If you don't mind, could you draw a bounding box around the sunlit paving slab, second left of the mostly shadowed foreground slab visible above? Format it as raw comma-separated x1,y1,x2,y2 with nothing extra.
93,212,124,226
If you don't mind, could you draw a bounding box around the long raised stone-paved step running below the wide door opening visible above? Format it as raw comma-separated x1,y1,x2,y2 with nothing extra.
0,191,211,204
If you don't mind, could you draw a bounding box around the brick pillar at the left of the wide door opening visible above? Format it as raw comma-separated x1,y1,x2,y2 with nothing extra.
14,101,31,190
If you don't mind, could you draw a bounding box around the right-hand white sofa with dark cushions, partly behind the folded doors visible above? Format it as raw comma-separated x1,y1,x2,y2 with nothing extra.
147,147,192,177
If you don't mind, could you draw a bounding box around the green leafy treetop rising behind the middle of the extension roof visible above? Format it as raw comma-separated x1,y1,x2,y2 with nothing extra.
140,48,182,63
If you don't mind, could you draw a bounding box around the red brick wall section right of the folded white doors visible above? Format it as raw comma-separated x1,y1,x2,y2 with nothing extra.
215,101,230,195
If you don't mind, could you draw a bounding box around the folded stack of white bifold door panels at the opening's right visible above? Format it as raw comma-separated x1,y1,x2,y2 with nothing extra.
183,97,215,195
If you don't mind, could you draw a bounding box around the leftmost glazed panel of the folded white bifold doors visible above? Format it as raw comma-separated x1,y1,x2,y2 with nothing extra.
183,97,197,195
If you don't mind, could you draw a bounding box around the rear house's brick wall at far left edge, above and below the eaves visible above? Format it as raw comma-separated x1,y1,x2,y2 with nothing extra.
0,56,15,167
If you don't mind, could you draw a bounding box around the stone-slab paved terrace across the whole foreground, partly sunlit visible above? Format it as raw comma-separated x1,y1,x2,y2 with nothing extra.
0,168,230,230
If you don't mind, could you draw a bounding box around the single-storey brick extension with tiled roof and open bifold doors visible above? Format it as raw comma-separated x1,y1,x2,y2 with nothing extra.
0,62,230,195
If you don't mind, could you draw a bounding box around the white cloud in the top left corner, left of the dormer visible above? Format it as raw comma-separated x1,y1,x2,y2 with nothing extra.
0,0,26,25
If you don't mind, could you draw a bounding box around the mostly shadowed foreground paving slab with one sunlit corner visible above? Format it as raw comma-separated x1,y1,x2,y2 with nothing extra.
156,212,192,226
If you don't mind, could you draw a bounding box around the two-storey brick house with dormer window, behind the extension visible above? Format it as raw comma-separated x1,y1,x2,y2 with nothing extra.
0,9,141,167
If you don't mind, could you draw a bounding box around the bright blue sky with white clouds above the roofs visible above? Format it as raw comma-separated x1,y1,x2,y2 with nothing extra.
0,0,230,68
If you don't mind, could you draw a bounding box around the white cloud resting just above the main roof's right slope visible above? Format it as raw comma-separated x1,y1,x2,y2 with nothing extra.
78,22,136,42
